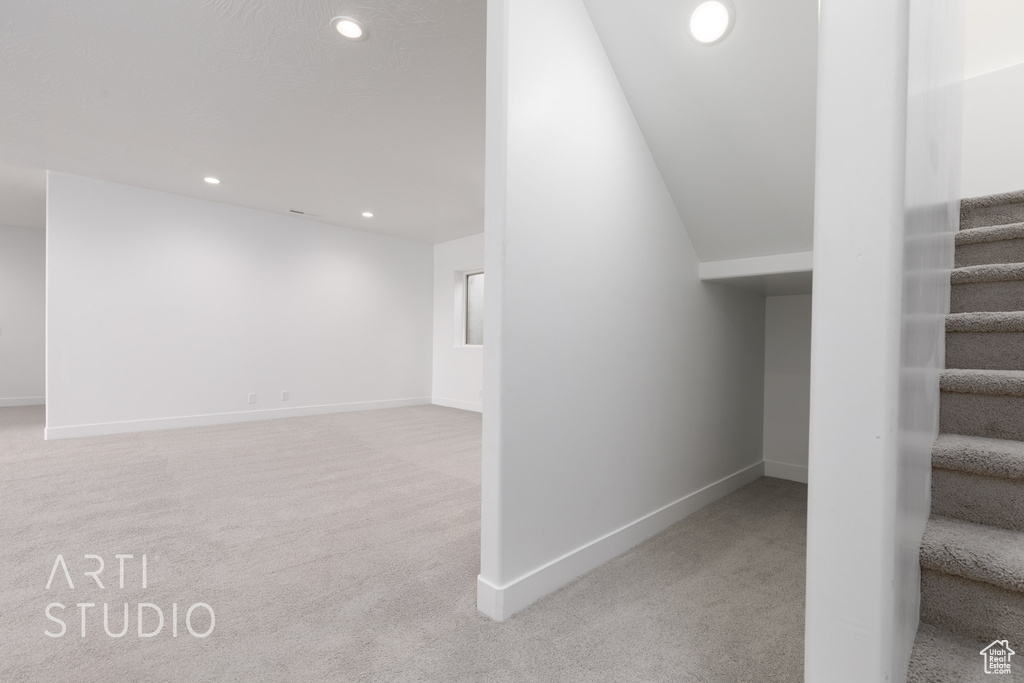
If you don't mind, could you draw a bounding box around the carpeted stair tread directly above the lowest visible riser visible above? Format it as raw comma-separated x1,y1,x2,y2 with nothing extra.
921,515,1024,593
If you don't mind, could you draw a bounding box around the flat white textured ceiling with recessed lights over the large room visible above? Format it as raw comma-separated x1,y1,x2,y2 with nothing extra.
0,0,485,243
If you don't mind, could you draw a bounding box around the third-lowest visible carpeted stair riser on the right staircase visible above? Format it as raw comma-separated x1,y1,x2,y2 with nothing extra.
939,391,1024,441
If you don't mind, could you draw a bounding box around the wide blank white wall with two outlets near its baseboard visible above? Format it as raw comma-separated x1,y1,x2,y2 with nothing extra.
46,173,433,437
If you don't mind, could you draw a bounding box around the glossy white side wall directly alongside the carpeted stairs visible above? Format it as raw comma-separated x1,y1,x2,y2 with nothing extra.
901,0,965,681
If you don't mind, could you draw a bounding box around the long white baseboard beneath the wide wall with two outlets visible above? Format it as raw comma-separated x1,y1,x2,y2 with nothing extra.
43,397,430,439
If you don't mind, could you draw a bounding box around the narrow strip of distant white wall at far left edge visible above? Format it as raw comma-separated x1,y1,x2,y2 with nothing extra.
0,225,46,407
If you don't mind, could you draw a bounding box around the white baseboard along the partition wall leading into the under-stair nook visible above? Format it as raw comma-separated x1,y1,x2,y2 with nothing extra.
476,462,764,622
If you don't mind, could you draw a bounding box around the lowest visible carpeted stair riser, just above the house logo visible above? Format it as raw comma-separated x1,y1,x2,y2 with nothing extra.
921,568,1024,642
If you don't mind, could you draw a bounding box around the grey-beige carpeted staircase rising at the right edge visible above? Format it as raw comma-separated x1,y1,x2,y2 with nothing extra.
908,191,1024,683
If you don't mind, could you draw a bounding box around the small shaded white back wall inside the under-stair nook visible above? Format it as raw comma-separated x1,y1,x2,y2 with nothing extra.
762,294,811,483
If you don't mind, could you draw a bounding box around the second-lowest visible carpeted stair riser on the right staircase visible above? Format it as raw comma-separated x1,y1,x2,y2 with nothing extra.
932,469,1024,531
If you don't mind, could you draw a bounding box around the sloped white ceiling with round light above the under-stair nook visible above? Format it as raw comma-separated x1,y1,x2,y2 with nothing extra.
584,0,818,261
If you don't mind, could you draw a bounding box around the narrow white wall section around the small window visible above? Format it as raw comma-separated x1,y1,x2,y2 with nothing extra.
433,232,486,412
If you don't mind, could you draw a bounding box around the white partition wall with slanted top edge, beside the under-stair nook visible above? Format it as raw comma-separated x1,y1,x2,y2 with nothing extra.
477,0,764,620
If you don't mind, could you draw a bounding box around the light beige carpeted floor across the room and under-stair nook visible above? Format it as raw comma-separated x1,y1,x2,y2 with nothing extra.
0,407,806,683
